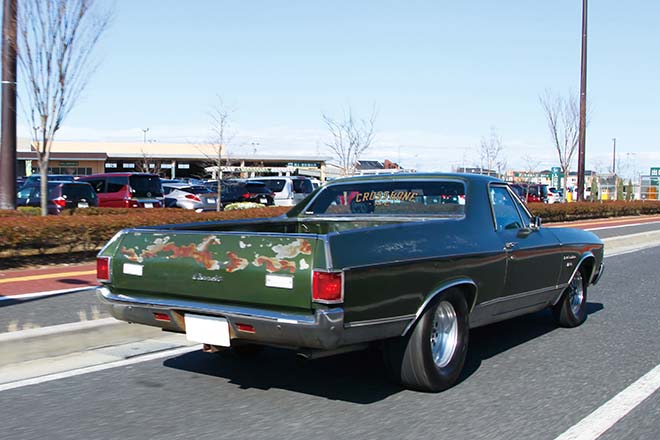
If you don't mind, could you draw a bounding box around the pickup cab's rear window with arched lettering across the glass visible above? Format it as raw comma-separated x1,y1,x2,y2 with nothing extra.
305,181,466,216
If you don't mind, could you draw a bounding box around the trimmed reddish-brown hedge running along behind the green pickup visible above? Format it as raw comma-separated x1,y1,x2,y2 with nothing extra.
0,201,660,255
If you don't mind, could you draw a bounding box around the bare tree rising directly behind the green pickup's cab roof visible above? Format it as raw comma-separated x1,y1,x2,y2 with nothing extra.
322,106,377,176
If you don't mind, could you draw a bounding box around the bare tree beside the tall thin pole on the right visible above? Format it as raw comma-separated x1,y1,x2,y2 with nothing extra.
539,90,580,199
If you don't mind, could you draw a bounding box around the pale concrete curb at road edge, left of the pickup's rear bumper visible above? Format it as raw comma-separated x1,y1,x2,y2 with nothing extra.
0,318,163,366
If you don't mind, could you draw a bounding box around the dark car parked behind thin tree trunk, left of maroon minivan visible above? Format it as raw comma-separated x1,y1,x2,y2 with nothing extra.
16,181,98,214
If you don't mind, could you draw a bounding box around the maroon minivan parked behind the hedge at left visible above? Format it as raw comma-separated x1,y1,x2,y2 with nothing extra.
79,173,164,208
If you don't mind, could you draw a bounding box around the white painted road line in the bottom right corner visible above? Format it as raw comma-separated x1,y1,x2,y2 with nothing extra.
555,364,660,440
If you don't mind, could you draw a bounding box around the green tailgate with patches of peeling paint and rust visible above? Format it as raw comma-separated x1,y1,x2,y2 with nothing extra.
111,231,325,309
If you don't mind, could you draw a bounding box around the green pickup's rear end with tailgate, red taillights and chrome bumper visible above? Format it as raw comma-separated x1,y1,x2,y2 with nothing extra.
97,229,343,348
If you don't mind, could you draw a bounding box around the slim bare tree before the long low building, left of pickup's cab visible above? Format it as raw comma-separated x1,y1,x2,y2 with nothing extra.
200,96,234,211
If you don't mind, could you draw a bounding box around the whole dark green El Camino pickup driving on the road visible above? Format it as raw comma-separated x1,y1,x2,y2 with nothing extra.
97,173,603,391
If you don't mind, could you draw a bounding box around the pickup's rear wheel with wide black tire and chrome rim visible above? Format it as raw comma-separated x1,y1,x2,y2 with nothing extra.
384,289,470,392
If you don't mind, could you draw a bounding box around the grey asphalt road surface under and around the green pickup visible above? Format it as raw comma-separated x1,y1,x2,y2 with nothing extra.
0,242,660,440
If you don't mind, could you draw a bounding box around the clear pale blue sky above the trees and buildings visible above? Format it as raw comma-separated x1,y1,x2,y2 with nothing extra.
12,0,660,177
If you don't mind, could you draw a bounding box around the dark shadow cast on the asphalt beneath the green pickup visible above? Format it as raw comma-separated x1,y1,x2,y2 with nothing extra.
164,303,603,404
